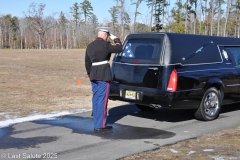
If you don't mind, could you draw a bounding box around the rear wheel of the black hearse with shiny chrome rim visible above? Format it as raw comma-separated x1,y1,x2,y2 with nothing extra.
194,87,221,121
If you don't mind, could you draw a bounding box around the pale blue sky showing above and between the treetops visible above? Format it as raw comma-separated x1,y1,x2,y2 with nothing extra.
0,0,154,22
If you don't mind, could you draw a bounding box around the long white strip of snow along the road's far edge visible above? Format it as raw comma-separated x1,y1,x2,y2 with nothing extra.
0,109,91,128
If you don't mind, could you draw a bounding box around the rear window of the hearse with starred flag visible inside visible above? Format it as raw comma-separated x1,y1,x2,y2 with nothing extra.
116,39,162,63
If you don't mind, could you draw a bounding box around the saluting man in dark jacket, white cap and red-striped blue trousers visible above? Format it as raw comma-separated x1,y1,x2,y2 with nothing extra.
85,27,122,131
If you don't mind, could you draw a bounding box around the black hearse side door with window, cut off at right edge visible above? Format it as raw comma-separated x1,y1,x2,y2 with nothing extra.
222,46,240,101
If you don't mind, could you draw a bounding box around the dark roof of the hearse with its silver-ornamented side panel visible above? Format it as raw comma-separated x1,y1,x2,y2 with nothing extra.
126,32,240,66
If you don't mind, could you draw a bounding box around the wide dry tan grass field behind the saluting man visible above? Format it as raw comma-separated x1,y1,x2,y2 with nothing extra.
0,49,124,120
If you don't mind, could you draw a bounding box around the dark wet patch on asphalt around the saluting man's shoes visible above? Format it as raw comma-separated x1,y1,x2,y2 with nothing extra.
35,116,175,139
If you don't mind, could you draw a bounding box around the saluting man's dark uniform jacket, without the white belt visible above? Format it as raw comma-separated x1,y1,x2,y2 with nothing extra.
85,38,122,81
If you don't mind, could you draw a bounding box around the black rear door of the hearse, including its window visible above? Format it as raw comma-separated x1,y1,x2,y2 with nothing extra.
112,34,164,90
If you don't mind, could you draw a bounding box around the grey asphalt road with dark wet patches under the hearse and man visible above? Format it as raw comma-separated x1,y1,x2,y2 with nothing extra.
0,104,240,160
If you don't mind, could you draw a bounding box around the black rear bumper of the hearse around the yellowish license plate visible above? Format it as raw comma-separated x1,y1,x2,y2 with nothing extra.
109,84,202,109
